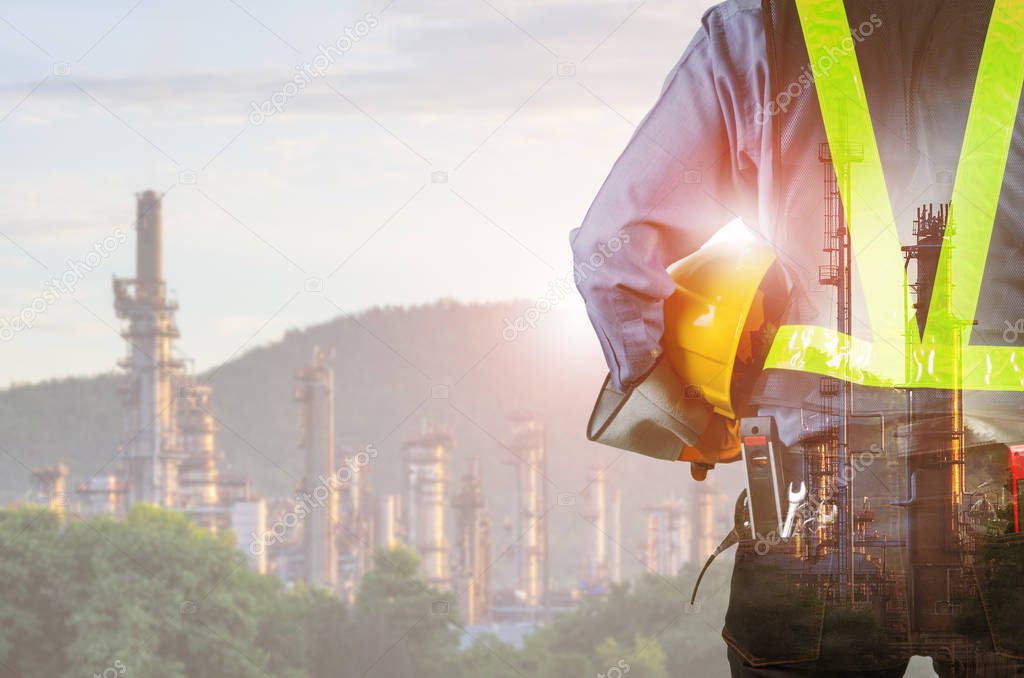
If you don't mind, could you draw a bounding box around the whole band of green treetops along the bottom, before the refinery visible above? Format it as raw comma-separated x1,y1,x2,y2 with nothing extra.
0,506,741,678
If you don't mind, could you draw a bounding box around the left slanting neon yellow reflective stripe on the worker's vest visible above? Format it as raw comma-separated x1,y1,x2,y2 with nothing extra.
797,0,906,380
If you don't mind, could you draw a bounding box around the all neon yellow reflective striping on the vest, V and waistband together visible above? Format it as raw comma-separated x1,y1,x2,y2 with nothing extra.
765,0,1024,390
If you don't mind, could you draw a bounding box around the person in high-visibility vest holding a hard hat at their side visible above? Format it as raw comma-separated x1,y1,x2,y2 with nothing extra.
570,0,1024,676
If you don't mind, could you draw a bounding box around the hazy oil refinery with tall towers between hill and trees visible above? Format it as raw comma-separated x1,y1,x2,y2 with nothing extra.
27,190,725,625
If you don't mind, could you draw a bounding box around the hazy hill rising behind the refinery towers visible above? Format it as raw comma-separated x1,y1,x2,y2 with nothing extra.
0,302,738,583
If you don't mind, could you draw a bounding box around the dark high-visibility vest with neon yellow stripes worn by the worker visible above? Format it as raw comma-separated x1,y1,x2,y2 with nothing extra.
758,0,1024,407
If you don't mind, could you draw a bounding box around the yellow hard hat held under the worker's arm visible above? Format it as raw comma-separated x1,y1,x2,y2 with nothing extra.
662,239,782,477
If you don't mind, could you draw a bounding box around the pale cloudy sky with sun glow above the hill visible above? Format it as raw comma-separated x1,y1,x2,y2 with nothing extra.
0,0,708,386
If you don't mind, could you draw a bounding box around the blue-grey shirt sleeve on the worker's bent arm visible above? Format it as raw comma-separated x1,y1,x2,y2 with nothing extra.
570,6,764,389
